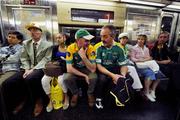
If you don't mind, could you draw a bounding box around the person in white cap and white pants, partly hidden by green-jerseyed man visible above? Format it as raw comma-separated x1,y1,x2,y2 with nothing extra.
118,33,142,90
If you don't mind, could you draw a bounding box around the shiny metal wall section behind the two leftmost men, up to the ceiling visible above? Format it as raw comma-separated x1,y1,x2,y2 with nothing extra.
0,0,58,45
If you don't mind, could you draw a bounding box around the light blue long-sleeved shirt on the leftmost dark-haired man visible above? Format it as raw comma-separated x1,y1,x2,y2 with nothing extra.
0,44,22,72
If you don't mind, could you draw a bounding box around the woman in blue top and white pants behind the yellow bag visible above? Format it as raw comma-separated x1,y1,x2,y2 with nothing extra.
41,33,69,112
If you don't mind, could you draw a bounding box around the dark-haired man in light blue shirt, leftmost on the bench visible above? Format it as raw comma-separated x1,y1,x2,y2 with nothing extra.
0,31,23,85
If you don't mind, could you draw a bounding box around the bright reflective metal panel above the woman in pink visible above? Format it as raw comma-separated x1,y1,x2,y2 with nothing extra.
127,13,158,41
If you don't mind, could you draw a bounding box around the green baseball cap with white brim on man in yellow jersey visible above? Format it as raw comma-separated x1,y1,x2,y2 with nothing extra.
75,29,94,40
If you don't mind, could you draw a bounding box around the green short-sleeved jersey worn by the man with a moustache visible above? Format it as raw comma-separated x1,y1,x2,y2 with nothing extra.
96,45,126,69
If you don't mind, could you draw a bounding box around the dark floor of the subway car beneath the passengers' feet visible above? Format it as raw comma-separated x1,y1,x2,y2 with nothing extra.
3,80,176,120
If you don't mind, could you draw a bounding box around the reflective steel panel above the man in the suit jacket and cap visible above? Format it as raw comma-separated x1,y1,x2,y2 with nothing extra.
1,4,53,44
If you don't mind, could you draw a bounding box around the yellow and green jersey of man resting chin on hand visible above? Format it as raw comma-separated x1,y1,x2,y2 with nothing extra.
66,43,95,68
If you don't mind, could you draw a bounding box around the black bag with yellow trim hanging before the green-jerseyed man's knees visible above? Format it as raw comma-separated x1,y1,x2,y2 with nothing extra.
110,76,133,106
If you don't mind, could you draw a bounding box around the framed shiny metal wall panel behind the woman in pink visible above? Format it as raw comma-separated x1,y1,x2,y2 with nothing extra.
124,8,161,43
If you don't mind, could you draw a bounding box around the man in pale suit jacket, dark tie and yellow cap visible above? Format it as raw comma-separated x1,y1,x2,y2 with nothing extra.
2,23,52,116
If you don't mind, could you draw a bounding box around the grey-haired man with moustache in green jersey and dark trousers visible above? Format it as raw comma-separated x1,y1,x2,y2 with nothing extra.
94,25,128,109
